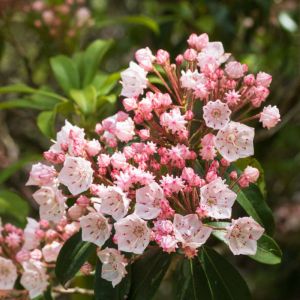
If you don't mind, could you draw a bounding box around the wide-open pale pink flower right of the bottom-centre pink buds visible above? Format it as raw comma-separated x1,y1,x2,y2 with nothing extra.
173,214,212,249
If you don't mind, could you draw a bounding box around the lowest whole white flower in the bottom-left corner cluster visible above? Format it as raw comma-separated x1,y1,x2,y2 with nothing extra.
20,260,48,299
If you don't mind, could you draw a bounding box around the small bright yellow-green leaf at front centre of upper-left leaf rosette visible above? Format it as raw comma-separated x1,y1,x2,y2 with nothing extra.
70,85,97,115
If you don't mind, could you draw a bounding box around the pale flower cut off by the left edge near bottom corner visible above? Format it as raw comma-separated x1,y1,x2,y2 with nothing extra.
0,256,18,290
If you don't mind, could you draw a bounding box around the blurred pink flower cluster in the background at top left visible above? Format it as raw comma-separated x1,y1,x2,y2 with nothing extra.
24,0,93,38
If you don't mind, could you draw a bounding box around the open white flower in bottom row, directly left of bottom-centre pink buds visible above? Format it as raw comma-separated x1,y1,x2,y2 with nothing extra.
114,214,151,254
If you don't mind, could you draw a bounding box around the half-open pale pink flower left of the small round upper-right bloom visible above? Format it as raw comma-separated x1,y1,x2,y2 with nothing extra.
160,107,187,134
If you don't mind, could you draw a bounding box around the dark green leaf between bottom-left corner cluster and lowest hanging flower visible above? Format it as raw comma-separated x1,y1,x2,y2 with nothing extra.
55,231,96,285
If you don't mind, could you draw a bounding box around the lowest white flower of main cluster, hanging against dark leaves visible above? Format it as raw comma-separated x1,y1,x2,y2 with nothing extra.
97,248,127,287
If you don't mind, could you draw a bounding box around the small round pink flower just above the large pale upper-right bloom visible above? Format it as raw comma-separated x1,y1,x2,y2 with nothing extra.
203,100,231,129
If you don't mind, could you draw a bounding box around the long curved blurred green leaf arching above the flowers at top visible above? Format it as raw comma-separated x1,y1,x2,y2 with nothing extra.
96,16,159,34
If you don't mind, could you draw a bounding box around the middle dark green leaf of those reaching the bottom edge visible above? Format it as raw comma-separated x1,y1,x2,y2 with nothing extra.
174,258,213,300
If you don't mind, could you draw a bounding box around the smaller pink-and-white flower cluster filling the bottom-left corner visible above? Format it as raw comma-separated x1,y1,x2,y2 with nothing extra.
0,218,79,299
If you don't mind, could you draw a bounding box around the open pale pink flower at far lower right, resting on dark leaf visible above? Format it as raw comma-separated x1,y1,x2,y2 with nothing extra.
226,217,265,255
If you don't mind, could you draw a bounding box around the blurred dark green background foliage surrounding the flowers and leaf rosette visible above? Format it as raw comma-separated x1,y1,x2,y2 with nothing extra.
0,0,300,300
